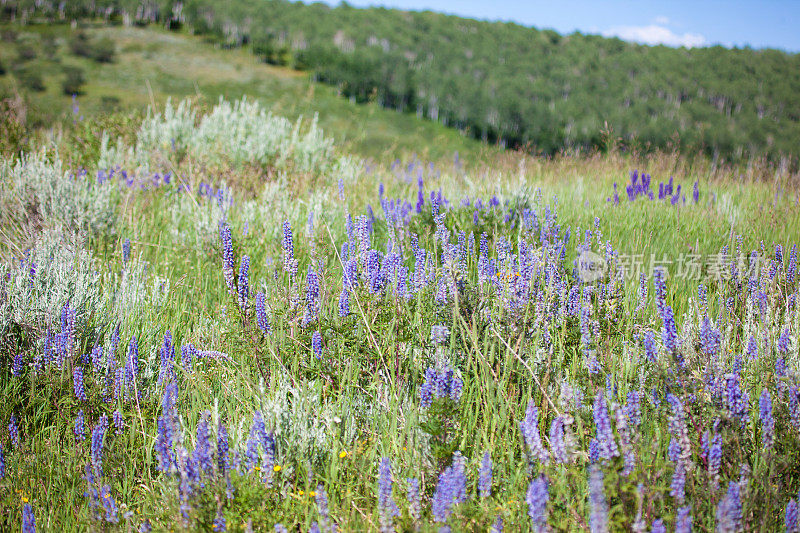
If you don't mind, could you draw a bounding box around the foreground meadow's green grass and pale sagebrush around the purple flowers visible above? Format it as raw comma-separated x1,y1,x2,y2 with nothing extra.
0,96,800,532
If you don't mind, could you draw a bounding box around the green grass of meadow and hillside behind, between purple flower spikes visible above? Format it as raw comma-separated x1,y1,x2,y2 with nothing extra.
0,23,800,531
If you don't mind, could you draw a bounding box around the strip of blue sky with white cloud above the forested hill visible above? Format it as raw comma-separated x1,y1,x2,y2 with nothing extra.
312,0,800,52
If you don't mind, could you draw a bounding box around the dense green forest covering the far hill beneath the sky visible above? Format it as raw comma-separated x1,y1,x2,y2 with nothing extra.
2,0,800,160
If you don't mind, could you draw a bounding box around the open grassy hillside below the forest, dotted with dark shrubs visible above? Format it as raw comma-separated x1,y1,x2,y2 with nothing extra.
0,25,497,161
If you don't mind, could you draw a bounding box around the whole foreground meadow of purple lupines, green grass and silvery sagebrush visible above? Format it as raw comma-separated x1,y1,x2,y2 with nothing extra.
0,100,800,532
